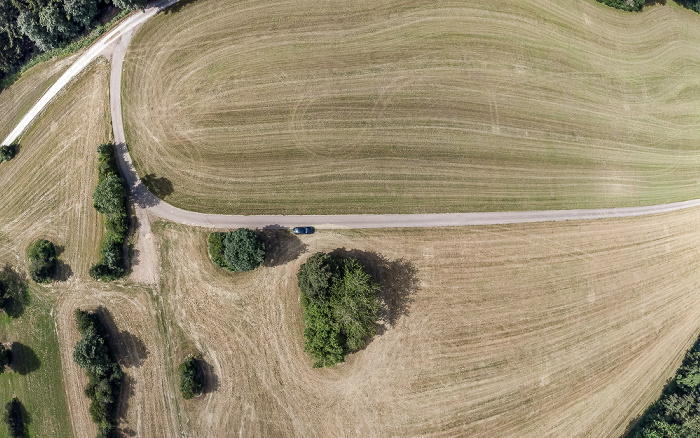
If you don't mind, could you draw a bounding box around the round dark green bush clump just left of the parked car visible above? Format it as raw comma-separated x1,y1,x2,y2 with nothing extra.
207,228,265,272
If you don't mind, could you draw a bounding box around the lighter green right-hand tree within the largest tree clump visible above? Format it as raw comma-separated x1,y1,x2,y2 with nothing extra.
331,259,379,351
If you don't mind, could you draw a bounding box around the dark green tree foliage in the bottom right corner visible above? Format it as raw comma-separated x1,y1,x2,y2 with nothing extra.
628,340,700,438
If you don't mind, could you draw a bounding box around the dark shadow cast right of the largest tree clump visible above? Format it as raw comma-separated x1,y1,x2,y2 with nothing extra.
331,248,420,335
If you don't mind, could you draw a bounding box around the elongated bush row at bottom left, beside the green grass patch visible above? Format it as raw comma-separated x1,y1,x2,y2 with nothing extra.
73,309,124,438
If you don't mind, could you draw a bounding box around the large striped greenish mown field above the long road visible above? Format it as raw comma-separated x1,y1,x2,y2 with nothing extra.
123,0,700,214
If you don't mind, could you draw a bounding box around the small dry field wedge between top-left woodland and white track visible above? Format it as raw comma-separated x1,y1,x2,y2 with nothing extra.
0,54,77,141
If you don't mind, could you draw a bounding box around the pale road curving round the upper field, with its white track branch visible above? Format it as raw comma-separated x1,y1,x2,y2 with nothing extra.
3,0,700,228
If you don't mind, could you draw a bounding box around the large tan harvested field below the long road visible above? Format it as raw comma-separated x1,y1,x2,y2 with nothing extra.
153,209,700,438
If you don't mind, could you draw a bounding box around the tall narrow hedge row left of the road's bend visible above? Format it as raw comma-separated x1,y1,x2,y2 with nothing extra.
90,143,129,281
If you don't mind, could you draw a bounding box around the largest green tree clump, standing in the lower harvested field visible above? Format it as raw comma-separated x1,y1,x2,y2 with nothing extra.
297,252,379,367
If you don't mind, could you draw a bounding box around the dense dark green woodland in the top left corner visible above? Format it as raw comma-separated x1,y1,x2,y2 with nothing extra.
0,0,146,79
